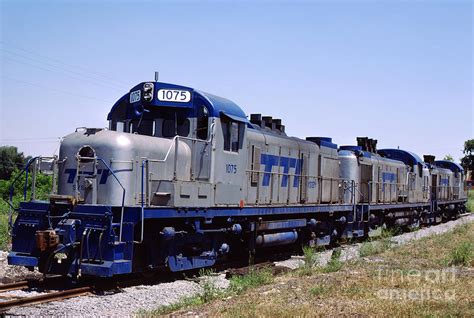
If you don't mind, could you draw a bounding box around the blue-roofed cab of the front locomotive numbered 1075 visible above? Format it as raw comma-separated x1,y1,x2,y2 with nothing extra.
102,82,247,207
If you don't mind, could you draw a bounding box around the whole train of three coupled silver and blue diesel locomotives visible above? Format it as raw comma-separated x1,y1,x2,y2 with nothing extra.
8,82,466,277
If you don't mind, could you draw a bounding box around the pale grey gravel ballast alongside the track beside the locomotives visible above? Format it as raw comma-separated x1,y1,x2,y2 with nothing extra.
0,214,474,317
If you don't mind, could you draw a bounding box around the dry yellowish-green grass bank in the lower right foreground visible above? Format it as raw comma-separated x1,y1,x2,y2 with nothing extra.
188,223,474,317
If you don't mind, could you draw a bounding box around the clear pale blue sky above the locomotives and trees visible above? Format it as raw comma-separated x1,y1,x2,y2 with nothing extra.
0,0,474,159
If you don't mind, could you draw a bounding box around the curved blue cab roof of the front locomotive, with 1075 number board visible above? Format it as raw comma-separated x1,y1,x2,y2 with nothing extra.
107,82,248,123
